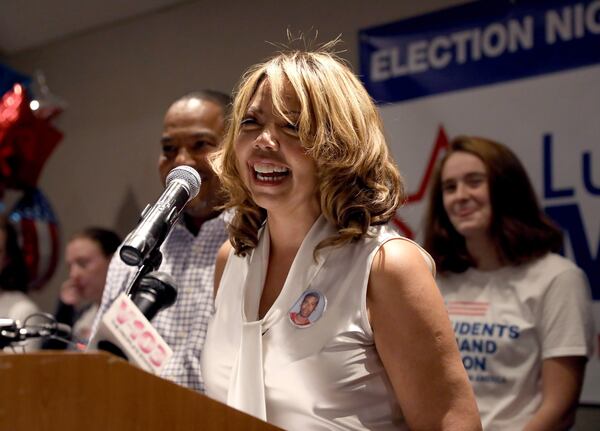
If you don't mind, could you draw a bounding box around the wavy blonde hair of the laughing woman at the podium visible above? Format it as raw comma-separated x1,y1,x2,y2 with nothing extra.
212,45,404,256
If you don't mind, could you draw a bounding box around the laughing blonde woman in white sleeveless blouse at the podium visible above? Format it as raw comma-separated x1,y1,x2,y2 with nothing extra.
202,45,481,431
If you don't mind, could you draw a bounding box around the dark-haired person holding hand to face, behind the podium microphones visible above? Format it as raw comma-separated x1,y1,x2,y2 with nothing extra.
43,227,121,349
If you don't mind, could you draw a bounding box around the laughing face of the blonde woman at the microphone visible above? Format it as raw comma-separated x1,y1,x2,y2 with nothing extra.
235,81,320,221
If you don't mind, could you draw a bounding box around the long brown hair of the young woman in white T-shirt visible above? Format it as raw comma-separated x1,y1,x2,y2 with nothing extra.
424,136,562,272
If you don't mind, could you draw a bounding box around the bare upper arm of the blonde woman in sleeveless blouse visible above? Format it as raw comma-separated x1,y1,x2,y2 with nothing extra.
367,240,481,431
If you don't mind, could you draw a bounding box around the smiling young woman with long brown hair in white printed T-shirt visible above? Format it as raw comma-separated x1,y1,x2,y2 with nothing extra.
424,136,593,431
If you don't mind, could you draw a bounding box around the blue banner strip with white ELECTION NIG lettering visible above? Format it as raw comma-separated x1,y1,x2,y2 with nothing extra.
359,0,600,103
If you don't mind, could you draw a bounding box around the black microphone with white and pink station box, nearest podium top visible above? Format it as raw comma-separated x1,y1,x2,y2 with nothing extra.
88,272,177,374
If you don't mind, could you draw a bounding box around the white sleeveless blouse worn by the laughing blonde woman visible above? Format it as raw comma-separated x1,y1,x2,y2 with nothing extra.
202,216,428,431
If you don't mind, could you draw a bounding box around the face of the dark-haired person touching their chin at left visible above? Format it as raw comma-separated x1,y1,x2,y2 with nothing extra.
66,238,110,303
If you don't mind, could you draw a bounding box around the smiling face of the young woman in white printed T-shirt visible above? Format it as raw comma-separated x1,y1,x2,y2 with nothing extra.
442,151,492,239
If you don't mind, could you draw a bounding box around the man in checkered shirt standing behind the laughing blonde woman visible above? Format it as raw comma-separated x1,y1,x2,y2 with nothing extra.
92,90,230,392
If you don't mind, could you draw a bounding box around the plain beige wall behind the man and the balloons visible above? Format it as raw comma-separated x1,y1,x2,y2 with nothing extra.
5,0,464,311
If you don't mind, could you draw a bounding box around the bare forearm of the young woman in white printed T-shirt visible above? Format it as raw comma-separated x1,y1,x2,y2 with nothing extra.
524,356,587,431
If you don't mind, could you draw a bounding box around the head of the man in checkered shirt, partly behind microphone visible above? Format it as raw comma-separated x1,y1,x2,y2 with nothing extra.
158,99,225,219
